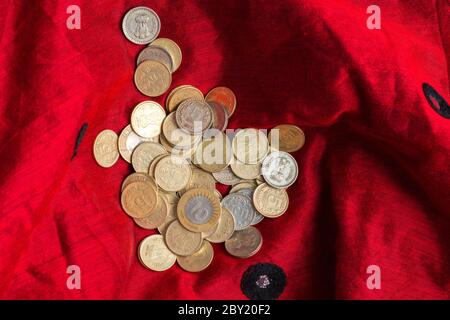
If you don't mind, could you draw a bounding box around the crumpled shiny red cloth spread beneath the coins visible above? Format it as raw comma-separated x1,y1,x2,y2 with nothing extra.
0,0,450,299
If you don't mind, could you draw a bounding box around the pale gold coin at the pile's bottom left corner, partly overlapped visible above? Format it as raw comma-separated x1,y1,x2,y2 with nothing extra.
138,234,177,271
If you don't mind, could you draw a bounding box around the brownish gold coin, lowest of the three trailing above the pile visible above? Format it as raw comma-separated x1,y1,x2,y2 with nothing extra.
134,60,172,97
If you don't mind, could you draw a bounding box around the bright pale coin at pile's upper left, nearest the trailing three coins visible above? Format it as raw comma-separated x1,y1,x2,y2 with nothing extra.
131,101,166,138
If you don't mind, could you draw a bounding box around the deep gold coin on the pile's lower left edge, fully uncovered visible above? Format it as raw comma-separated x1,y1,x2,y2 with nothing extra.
120,182,158,218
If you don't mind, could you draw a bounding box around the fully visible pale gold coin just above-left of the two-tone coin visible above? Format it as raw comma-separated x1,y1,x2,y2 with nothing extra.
155,155,191,192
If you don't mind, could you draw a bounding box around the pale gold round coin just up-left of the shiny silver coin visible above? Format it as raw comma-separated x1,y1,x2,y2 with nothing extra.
233,128,269,164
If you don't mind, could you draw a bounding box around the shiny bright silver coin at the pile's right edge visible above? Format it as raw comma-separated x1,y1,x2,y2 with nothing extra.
261,151,298,188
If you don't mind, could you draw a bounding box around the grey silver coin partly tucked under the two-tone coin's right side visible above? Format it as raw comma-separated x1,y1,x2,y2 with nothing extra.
222,193,255,230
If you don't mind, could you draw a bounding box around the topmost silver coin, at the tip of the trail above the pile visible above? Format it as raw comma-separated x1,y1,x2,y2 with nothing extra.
122,7,161,44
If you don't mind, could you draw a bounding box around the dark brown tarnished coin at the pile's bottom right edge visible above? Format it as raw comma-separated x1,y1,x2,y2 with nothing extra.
225,227,262,258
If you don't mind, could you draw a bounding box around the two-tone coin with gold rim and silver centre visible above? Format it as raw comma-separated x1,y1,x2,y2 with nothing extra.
177,189,222,232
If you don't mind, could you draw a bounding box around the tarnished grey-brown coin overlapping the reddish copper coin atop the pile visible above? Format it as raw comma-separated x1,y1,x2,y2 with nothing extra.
175,99,212,135
